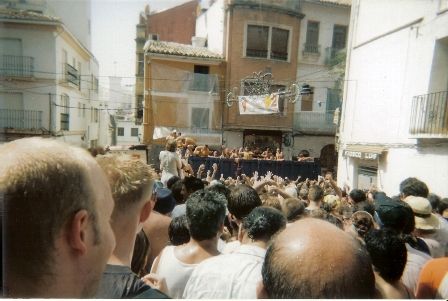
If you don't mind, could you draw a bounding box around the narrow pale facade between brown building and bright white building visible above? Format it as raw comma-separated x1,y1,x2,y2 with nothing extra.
293,0,351,172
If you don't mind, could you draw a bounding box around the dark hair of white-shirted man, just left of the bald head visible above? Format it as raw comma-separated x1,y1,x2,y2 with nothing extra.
242,206,286,242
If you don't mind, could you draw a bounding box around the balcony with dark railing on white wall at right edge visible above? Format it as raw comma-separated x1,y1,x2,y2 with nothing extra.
409,91,448,138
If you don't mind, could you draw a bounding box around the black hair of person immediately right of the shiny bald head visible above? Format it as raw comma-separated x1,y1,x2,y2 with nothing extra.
364,228,407,282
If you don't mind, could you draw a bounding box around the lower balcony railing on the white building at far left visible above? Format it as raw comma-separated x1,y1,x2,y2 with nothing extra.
0,109,42,130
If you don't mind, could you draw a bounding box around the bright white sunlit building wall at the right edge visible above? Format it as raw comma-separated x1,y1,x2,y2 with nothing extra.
338,0,448,197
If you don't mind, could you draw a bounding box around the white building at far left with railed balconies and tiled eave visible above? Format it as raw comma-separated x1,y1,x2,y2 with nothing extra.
0,0,99,148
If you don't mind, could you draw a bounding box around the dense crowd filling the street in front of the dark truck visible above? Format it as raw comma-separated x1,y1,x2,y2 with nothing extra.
0,138,448,299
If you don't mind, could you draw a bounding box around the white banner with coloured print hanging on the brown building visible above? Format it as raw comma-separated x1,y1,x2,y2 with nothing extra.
238,93,280,115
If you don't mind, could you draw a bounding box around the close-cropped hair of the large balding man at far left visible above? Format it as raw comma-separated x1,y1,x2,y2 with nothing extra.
0,138,101,287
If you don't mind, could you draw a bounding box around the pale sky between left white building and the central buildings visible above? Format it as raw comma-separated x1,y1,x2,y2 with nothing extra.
91,0,187,86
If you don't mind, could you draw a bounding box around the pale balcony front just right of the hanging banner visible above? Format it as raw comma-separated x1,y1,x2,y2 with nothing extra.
293,112,336,134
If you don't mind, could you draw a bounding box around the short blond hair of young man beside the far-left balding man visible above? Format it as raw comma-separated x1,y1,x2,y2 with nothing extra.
96,154,157,211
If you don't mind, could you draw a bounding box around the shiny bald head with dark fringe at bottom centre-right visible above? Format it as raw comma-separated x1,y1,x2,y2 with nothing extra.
262,218,375,299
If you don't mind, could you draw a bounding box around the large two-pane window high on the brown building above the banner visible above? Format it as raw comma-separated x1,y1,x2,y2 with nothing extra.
246,25,290,61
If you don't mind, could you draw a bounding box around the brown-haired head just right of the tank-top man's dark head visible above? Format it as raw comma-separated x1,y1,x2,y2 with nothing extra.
228,184,262,220
